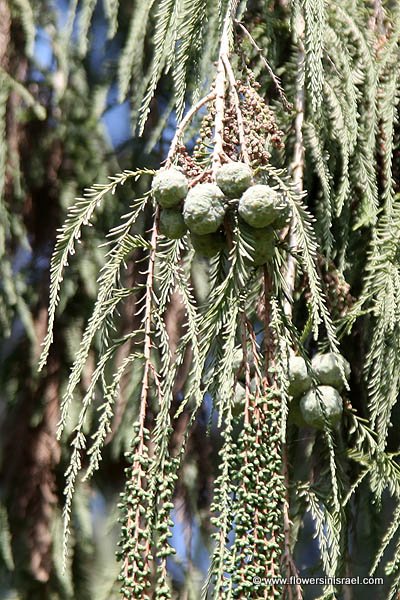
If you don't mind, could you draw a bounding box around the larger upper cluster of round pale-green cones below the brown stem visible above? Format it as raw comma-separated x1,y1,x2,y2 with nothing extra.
151,161,290,266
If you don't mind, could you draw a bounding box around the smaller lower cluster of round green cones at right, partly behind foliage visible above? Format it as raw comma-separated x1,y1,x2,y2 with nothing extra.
288,352,350,429
